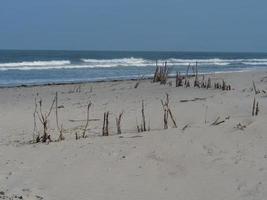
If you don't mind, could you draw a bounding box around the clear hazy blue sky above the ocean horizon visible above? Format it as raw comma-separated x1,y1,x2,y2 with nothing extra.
0,0,267,52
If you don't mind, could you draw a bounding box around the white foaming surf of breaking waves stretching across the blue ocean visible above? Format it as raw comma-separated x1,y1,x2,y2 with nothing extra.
0,57,267,71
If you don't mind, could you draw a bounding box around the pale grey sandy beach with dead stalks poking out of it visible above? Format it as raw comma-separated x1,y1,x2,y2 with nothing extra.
0,70,267,200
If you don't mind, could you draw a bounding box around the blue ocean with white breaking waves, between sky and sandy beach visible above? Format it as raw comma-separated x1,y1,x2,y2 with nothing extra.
0,50,267,87
